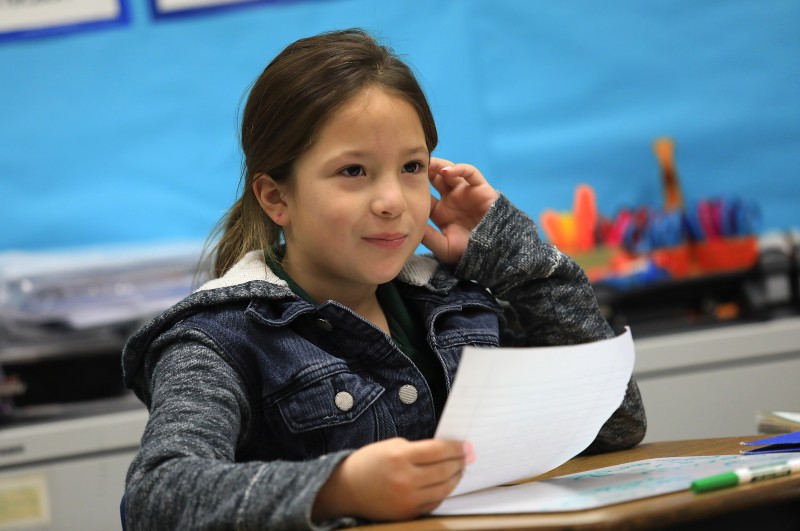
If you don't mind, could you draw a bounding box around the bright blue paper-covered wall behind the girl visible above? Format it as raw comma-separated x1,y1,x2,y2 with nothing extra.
0,0,800,251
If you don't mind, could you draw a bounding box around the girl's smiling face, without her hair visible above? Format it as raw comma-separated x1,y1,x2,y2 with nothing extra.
281,88,430,302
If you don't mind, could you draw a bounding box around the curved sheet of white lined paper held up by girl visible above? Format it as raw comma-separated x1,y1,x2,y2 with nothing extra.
435,328,635,496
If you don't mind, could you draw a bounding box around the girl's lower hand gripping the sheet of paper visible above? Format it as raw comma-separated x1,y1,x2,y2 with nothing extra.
312,437,474,522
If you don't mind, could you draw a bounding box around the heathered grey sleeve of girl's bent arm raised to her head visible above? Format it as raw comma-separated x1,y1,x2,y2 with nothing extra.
456,194,647,453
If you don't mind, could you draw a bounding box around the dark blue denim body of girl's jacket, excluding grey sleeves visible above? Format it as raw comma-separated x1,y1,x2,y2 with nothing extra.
178,264,500,460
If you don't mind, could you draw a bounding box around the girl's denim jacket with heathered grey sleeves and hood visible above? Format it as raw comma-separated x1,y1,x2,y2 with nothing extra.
123,195,645,529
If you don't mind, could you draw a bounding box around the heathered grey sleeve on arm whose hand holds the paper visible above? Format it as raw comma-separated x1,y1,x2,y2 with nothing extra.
125,332,355,531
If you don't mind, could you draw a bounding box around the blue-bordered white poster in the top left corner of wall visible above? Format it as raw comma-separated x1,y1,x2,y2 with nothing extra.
0,0,129,41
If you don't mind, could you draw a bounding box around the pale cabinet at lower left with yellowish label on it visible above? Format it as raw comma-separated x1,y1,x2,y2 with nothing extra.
0,406,147,531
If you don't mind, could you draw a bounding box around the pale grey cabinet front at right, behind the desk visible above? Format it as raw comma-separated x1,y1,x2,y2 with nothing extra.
632,317,800,442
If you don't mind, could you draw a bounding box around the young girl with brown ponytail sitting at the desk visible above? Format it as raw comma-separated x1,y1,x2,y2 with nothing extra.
123,30,645,530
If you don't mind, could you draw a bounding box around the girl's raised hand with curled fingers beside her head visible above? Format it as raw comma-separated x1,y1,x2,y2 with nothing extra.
422,157,497,264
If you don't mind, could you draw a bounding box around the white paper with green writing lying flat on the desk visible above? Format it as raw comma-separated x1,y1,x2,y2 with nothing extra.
433,453,800,516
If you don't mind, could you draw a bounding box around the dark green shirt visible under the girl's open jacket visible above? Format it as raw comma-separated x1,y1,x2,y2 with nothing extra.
267,251,447,420
